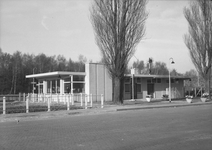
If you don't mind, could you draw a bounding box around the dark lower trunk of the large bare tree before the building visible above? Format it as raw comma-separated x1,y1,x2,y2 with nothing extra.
113,77,123,104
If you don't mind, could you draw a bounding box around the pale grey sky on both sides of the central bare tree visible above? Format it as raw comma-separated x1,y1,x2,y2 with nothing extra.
0,0,194,73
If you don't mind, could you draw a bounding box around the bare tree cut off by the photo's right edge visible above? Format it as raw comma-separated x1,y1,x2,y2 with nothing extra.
184,0,212,99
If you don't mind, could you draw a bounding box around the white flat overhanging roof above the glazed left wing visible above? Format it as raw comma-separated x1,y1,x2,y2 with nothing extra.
26,71,86,78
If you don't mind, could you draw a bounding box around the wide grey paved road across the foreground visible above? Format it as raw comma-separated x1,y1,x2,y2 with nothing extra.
0,105,212,150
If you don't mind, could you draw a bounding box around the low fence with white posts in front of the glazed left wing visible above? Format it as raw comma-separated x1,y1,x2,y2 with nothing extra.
0,93,104,114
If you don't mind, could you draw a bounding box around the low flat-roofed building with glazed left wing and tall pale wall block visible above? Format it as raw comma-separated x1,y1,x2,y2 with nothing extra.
26,63,189,101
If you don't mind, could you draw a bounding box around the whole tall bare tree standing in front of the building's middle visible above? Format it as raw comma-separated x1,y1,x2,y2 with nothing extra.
90,0,148,103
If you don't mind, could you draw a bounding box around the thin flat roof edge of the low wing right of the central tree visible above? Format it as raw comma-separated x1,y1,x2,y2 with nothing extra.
125,74,191,80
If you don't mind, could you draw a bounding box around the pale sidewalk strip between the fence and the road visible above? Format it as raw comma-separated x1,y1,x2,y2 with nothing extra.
0,99,212,123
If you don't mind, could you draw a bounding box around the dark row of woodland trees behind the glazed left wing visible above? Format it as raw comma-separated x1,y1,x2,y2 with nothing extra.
0,49,87,94
